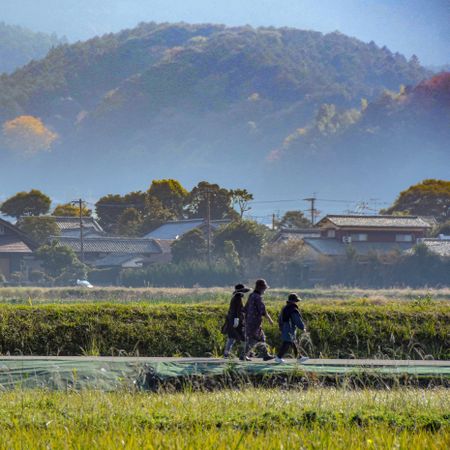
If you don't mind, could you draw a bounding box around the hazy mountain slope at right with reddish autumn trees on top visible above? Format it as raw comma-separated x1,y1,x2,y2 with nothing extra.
268,72,450,200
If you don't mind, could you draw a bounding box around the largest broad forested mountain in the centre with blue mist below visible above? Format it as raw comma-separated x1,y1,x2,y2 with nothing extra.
0,23,440,203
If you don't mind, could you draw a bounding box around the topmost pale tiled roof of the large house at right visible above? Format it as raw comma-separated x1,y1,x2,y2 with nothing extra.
318,215,430,228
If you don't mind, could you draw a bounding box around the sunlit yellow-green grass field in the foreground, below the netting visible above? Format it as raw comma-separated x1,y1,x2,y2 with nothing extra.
0,388,450,449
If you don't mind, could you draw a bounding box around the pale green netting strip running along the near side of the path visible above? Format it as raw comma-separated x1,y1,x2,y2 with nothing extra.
0,357,450,391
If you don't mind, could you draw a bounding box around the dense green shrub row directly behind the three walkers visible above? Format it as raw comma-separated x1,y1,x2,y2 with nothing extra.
0,302,450,359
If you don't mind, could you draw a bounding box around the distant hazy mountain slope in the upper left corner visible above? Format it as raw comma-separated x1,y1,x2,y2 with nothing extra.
0,22,65,74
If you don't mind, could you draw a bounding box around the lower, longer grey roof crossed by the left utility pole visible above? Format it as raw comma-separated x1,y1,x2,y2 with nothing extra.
56,236,161,254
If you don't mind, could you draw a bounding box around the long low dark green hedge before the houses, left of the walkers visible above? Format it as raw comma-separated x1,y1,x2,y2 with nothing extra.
121,261,239,287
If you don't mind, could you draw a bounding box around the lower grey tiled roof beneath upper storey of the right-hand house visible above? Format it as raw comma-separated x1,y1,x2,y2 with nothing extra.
304,238,414,256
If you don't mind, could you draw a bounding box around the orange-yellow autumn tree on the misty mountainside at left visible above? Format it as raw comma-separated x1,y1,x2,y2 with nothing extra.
3,116,58,155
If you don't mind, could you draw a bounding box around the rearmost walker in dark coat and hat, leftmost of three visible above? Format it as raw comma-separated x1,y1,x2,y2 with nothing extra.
222,284,250,358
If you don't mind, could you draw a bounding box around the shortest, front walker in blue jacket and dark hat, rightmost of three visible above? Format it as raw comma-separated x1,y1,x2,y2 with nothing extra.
275,294,308,363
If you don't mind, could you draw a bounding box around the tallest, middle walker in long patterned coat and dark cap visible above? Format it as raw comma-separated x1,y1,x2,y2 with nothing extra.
241,279,274,361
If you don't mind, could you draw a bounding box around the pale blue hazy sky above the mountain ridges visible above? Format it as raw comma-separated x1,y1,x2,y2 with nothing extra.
0,0,450,65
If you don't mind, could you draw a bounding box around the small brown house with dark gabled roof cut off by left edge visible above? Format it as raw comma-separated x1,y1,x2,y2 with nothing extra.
0,219,37,279
